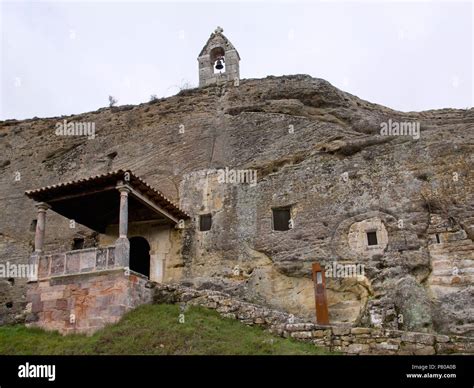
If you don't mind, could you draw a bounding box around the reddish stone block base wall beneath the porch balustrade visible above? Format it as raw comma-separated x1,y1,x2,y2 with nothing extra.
26,268,152,334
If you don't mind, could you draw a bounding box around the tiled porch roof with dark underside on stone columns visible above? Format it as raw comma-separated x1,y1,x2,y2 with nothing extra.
25,170,190,233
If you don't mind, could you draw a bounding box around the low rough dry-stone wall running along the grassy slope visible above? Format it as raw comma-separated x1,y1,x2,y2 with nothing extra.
153,284,474,355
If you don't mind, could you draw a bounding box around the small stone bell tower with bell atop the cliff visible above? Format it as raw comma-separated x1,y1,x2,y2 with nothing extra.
198,27,240,86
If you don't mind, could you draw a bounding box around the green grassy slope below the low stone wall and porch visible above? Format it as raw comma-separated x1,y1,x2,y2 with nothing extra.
0,304,330,355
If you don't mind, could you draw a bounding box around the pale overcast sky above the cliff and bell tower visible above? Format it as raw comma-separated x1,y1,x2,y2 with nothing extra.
0,1,474,119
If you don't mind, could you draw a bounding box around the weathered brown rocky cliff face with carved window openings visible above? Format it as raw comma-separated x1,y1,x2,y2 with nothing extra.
0,75,474,335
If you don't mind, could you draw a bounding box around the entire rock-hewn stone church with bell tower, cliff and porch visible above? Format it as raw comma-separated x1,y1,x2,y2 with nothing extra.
0,28,474,336
